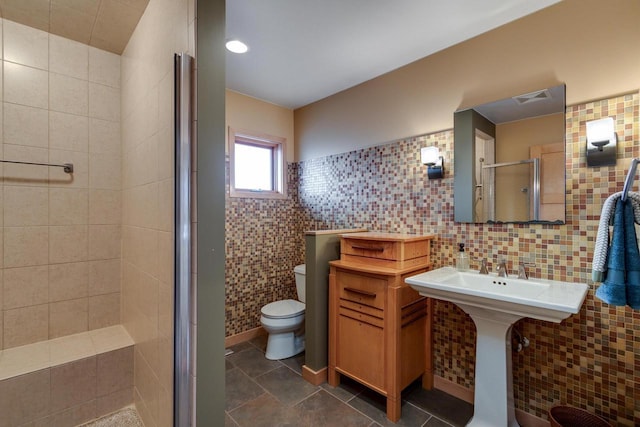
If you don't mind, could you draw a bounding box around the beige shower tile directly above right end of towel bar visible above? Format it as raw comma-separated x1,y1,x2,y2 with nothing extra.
49,111,89,152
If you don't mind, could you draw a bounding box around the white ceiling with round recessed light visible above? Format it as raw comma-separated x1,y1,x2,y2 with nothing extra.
226,0,559,109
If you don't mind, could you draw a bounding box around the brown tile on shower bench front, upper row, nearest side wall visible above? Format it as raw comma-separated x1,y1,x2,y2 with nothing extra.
97,346,133,396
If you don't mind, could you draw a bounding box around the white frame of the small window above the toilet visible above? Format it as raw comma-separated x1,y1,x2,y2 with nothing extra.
229,128,287,199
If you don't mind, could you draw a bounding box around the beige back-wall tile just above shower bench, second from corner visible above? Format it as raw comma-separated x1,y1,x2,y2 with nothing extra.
49,298,89,338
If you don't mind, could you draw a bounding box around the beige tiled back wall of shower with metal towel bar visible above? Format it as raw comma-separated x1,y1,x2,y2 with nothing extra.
0,19,121,349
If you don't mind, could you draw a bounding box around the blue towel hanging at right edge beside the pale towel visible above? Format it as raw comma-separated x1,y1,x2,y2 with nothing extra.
596,199,637,305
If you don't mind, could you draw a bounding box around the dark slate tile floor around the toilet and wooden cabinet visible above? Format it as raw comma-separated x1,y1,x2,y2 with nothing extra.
225,337,473,427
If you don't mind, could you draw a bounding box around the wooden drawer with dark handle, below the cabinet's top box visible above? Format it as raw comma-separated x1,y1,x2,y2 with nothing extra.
336,271,387,310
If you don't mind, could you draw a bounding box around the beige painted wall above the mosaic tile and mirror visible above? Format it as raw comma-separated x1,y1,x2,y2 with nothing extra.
295,0,640,160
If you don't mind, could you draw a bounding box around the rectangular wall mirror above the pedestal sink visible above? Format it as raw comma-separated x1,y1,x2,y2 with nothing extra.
453,85,565,224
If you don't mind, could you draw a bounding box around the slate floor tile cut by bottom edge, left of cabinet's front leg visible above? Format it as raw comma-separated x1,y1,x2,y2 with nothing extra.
296,390,371,427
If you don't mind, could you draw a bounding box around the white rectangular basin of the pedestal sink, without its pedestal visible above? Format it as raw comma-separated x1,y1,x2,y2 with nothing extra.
406,267,589,323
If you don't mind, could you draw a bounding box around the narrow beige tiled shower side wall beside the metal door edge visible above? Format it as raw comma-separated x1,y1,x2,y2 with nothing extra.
122,0,194,427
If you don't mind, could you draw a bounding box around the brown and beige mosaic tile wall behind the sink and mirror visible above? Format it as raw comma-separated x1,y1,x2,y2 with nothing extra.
294,93,640,426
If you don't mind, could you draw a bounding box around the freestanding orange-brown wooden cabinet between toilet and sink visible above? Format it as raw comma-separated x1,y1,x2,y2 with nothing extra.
328,233,433,422
